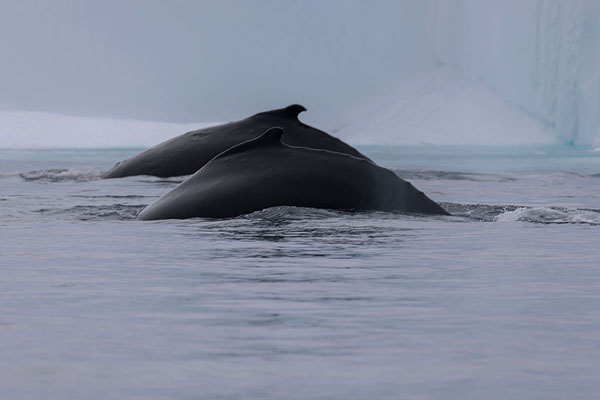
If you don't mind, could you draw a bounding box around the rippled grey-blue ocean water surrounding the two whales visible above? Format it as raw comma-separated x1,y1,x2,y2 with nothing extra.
0,146,600,400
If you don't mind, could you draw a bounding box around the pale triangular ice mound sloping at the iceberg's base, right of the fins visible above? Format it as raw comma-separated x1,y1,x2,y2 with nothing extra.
328,67,557,145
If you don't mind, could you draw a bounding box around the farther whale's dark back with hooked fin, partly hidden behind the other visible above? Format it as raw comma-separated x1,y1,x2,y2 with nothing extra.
102,104,366,178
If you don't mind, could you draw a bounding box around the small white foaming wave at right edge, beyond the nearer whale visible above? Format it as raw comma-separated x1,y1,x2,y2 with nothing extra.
494,207,600,225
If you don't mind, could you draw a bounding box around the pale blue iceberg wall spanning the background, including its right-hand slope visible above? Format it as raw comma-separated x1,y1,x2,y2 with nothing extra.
0,0,600,147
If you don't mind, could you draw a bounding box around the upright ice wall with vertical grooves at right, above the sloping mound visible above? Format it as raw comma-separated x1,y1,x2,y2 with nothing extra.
436,0,600,144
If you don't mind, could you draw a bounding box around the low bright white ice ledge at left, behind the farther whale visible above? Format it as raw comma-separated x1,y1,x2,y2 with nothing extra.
0,111,214,148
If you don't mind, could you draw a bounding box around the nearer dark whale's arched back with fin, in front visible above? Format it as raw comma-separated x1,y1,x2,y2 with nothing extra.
137,127,448,220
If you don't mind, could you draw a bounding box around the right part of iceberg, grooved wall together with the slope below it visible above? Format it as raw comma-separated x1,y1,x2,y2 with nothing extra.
332,0,600,146
